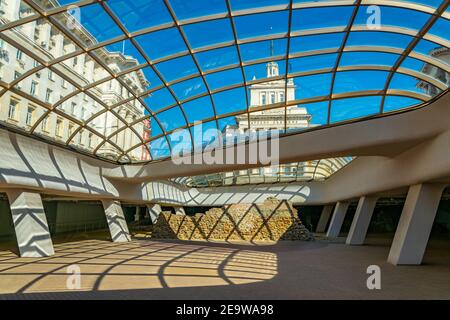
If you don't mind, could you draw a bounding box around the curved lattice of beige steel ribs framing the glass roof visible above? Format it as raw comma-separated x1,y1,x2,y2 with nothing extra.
0,0,450,163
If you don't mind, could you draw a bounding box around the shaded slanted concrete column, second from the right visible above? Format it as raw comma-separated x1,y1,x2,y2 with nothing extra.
346,196,378,245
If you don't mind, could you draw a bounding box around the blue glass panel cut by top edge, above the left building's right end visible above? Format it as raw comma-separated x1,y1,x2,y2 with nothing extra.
106,0,173,32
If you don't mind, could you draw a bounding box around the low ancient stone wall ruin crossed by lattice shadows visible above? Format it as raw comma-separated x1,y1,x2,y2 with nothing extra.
152,198,314,241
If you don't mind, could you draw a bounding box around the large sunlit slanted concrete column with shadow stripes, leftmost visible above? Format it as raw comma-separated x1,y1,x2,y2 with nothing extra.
7,190,55,257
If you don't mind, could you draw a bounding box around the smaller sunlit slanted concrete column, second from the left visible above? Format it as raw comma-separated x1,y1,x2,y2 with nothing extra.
102,200,131,242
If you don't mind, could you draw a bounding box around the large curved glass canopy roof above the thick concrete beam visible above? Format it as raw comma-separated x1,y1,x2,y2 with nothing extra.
0,0,450,163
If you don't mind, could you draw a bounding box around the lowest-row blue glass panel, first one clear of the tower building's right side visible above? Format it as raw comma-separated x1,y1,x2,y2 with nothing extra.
330,96,381,123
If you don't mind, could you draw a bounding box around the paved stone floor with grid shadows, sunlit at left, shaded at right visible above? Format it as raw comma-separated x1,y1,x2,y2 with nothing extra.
0,235,450,299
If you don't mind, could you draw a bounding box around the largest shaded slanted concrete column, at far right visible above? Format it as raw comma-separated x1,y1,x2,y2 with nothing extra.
388,184,445,265
